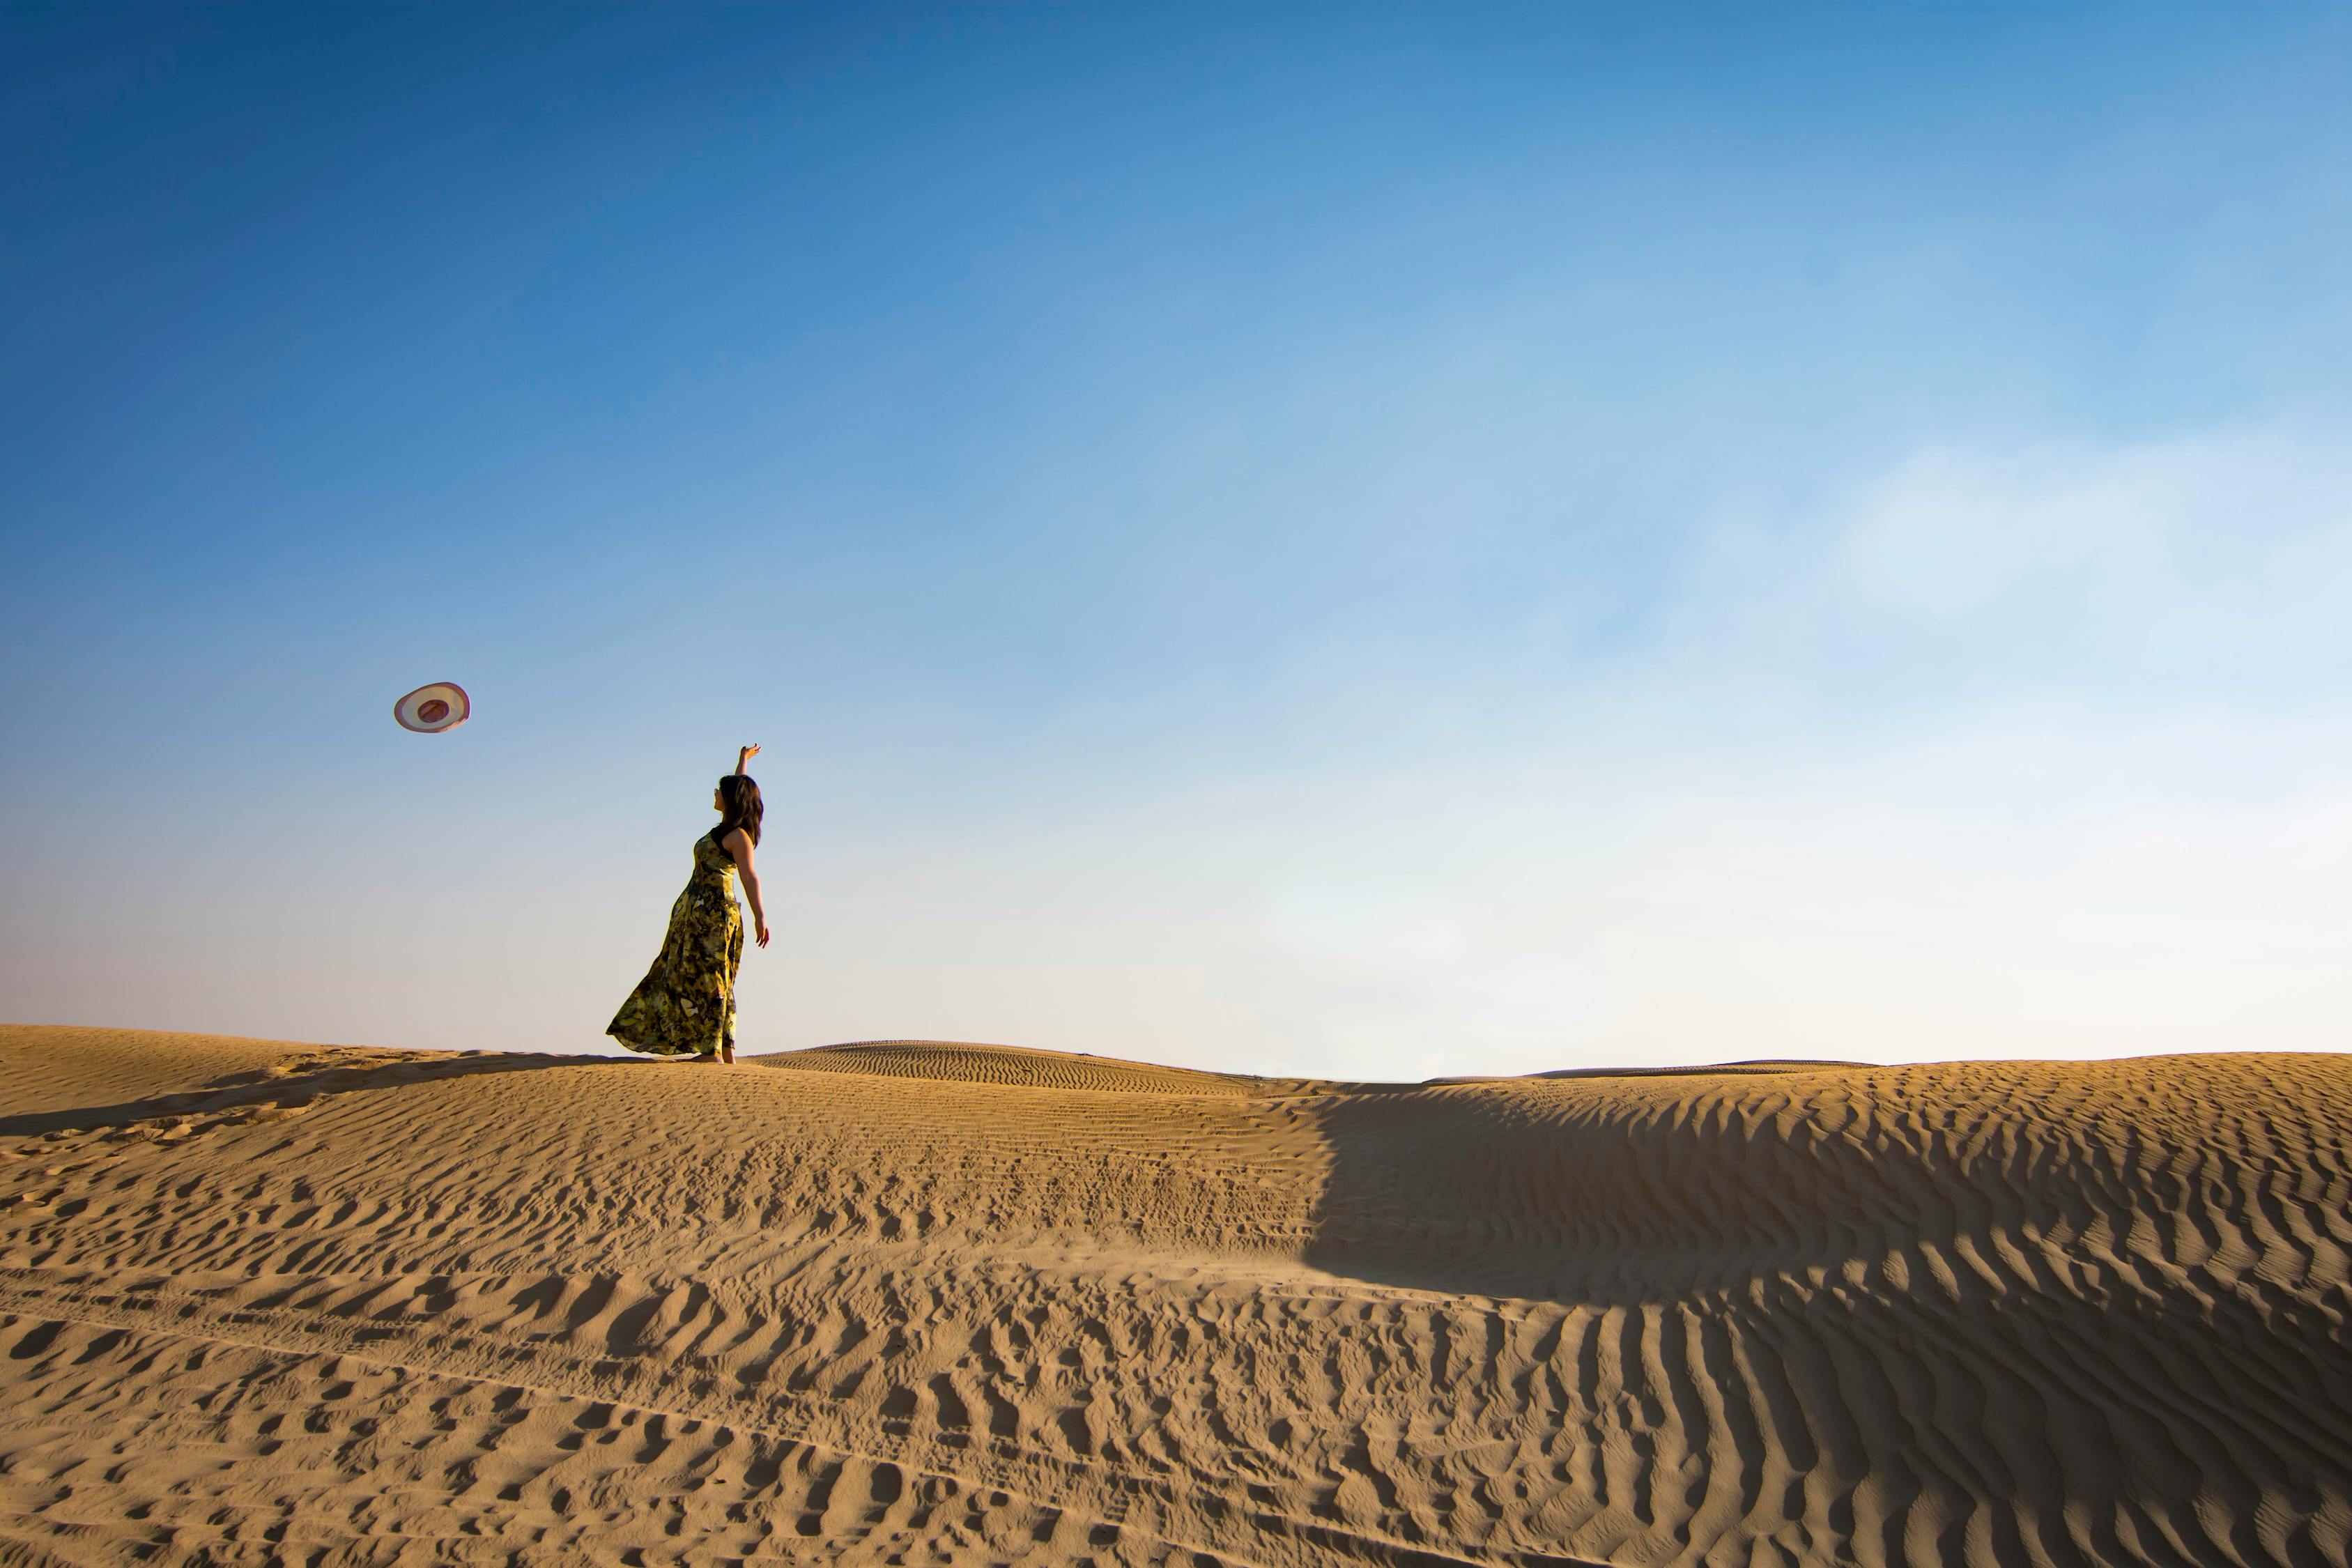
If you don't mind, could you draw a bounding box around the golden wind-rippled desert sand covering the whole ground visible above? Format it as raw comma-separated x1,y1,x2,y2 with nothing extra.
0,1027,2352,1568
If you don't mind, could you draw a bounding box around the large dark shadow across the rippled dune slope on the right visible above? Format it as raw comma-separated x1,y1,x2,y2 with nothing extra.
1303,1084,2352,1563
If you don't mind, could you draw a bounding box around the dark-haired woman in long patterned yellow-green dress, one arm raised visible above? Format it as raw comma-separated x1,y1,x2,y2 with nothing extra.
604,745,767,1063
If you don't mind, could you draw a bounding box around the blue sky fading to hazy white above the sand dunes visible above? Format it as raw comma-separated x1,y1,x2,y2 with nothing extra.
0,5,2352,1077
